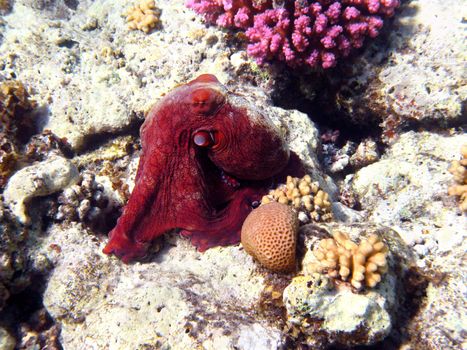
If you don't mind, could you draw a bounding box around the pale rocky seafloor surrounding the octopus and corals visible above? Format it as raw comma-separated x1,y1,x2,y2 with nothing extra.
0,0,467,350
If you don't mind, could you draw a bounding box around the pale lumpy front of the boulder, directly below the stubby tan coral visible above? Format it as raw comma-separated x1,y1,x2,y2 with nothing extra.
284,273,392,350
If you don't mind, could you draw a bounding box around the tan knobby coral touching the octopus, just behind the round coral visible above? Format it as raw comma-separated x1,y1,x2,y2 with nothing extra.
261,175,332,222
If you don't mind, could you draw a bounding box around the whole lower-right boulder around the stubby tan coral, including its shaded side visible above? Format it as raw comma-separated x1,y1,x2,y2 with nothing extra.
284,224,413,349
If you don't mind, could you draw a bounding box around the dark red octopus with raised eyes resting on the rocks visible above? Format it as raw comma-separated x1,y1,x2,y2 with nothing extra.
103,74,297,263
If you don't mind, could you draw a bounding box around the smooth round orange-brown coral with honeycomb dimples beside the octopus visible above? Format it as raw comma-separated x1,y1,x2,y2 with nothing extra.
241,202,299,272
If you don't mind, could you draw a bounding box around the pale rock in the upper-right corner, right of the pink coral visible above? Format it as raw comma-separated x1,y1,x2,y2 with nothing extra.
302,0,467,137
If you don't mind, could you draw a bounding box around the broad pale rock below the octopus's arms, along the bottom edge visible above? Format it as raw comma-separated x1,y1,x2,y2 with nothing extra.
43,224,283,349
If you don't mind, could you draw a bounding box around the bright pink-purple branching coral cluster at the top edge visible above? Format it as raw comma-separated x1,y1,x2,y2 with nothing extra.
186,0,400,68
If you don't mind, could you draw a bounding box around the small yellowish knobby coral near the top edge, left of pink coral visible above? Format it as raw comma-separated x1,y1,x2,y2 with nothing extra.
125,0,159,33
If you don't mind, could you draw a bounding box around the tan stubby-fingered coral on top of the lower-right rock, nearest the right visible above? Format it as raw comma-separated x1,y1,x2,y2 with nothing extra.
313,232,388,289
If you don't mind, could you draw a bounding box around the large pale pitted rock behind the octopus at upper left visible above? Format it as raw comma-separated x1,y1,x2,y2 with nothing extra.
0,0,278,150
